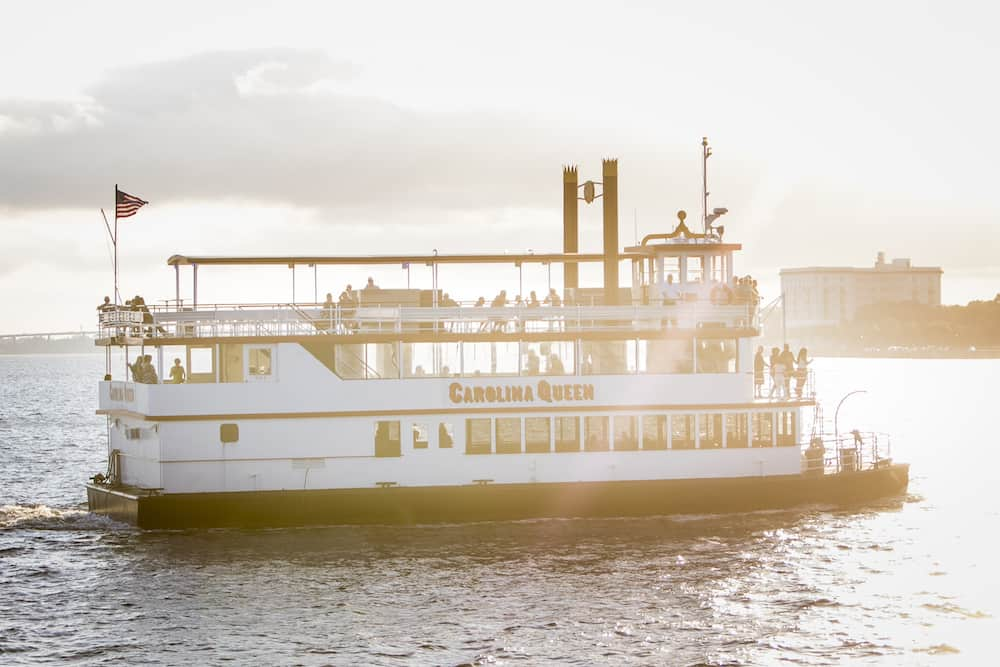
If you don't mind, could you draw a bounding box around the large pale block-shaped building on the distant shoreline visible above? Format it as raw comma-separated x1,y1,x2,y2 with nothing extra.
779,252,943,330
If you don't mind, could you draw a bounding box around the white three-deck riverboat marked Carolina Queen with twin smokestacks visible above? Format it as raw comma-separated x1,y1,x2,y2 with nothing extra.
86,154,909,528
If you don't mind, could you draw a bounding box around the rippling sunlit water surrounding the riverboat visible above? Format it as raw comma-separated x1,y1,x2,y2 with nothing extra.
0,355,1000,665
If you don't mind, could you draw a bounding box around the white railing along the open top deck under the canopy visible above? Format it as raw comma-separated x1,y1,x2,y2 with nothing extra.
99,301,759,338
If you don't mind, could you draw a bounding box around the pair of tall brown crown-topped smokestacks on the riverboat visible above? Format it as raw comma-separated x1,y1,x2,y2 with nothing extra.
563,159,618,305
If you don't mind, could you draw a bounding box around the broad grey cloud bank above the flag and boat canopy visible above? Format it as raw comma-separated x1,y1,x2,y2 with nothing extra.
0,49,616,215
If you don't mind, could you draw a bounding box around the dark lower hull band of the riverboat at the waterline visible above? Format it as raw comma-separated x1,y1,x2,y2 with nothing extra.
87,464,909,528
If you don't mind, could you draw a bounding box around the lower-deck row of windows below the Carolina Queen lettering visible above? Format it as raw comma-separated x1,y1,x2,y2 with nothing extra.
375,411,796,456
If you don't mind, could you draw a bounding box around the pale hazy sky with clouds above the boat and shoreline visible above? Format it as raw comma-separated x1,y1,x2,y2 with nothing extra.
0,1,1000,332
